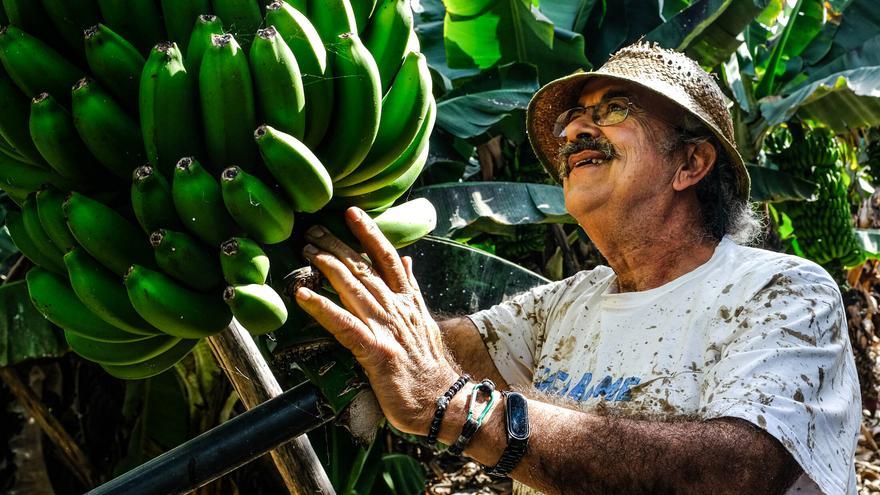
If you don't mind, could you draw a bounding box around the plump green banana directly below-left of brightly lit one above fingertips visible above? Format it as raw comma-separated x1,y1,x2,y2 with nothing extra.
220,167,293,244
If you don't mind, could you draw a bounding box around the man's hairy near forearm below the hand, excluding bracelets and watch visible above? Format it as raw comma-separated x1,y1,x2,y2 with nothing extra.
440,397,801,494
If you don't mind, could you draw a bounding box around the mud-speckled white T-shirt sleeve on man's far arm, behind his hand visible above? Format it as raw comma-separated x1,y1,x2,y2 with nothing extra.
469,272,584,388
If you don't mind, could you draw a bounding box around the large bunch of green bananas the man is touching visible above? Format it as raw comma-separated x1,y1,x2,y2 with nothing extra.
0,0,436,379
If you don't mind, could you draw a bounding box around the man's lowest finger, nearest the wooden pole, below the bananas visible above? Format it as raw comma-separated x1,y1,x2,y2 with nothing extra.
296,287,376,361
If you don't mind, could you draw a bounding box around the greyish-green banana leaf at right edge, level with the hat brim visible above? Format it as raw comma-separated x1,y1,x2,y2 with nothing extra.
761,66,880,132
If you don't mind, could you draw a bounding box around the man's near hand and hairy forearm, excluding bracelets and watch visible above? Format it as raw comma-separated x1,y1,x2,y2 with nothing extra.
296,209,796,494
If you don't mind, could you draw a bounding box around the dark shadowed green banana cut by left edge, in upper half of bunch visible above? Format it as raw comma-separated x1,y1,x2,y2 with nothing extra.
0,69,45,167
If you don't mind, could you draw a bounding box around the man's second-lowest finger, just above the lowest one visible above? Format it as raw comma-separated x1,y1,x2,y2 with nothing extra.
303,244,385,321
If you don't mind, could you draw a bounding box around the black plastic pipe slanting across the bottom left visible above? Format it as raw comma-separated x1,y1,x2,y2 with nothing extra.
87,383,333,495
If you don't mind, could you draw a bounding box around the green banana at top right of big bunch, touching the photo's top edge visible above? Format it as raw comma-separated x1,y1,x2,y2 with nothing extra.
363,0,413,94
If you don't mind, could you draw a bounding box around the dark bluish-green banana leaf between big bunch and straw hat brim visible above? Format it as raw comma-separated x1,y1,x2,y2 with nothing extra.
437,64,539,140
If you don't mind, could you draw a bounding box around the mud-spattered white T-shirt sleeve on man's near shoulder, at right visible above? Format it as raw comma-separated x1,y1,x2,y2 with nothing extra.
700,263,861,494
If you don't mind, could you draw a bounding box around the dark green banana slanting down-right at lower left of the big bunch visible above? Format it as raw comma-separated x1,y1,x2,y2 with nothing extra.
62,192,153,276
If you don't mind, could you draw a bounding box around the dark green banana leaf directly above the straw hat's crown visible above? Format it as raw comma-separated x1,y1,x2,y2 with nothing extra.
645,0,768,67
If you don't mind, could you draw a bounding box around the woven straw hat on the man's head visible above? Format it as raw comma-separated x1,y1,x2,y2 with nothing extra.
526,42,750,201
